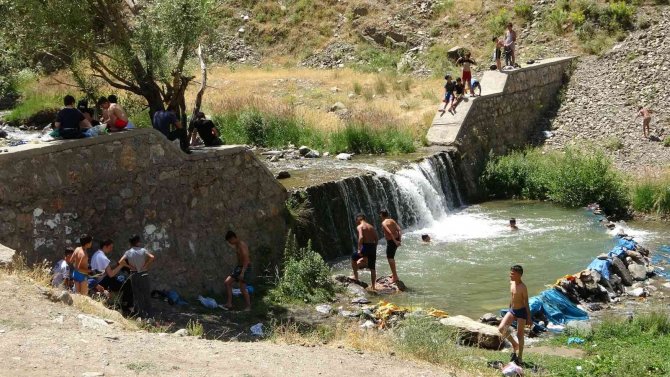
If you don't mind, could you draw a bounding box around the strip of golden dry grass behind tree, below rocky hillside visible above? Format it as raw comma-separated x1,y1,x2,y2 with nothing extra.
188,67,442,134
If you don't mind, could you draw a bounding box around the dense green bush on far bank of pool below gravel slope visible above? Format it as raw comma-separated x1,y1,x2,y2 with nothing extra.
482,149,629,215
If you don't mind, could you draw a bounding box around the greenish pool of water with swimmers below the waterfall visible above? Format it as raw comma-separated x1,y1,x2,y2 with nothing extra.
334,201,670,318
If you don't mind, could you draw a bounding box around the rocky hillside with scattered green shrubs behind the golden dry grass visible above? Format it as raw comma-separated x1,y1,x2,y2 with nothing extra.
210,0,588,74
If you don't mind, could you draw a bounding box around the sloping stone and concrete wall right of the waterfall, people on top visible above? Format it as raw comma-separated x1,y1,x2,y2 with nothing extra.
427,57,574,201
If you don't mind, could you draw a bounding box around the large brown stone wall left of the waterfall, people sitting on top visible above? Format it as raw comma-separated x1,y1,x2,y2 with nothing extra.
0,130,287,293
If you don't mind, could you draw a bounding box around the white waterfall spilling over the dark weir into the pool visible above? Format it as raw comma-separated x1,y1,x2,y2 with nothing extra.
299,153,464,257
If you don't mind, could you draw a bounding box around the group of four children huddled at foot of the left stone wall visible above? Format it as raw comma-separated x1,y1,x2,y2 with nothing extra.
51,234,155,318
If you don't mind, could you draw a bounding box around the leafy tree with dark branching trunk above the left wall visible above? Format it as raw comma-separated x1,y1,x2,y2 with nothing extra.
0,0,220,119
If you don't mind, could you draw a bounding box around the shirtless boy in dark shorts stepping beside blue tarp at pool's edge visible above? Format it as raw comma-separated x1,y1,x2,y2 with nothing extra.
498,264,533,365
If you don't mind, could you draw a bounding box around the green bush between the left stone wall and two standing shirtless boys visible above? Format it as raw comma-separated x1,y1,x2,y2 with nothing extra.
268,232,335,303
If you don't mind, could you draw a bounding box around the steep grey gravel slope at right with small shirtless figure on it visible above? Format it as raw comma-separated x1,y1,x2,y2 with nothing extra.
546,6,670,175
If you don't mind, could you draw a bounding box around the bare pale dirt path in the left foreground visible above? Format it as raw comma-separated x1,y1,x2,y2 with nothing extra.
0,273,451,377
